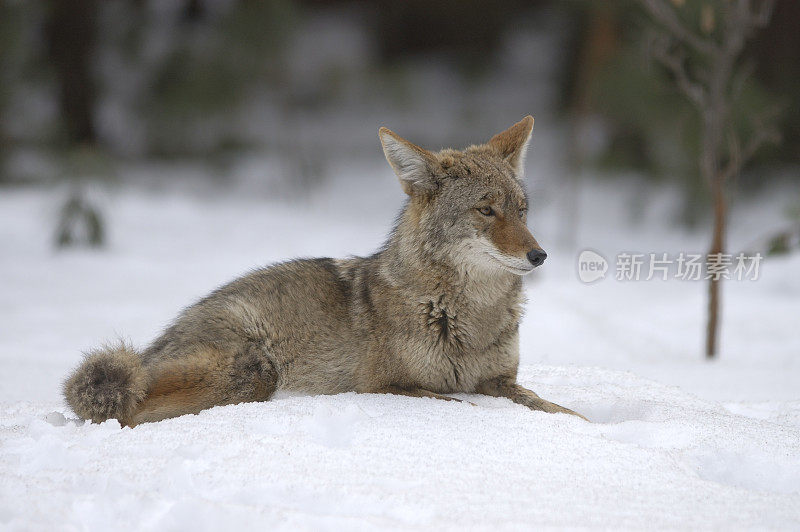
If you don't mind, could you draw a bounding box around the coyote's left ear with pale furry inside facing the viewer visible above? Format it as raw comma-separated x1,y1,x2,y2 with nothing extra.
378,127,437,196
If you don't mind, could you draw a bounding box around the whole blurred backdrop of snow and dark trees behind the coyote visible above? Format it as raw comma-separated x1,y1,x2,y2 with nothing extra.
0,0,800,386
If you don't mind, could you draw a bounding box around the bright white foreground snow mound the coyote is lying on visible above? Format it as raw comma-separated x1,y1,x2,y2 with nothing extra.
0,366,800,530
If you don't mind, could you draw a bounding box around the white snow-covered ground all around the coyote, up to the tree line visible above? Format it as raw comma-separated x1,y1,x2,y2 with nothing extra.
0,160,800,530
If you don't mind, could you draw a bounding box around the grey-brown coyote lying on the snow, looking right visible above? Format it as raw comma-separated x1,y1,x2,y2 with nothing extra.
64,116,585,427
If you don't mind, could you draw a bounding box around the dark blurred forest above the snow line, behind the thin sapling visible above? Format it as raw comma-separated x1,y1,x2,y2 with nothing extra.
0,0,800,245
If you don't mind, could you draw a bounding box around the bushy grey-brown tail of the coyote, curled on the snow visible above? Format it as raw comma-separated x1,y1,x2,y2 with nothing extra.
64,343,149,423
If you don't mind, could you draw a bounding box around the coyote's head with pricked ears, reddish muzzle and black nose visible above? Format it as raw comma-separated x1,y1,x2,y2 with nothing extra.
378,116,547,275
